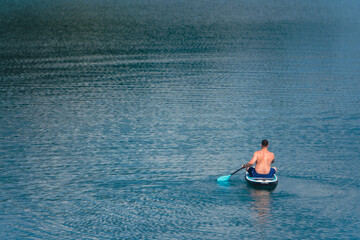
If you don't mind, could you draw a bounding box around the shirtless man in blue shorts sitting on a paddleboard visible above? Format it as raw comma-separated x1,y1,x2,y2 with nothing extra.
242,140,276,178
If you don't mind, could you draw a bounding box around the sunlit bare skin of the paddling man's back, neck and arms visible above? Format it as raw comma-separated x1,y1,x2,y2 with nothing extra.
243,142,277,174
